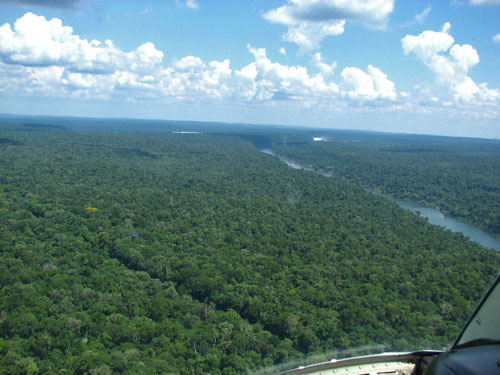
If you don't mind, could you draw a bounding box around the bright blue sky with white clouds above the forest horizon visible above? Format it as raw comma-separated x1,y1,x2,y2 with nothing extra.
0,0,500,138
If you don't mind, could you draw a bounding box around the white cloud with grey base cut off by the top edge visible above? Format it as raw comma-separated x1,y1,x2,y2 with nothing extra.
264,0,394,50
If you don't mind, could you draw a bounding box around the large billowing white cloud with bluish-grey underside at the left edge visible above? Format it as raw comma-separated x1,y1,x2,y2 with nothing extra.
0,13,163,73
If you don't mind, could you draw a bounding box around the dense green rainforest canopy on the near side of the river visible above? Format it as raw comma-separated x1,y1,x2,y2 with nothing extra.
0,120,500,374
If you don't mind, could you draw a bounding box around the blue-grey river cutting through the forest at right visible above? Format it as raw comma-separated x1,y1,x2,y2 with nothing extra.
261,150,500,251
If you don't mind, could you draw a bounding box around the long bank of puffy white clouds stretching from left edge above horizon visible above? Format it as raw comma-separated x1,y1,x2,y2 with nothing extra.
0,13,400,111
